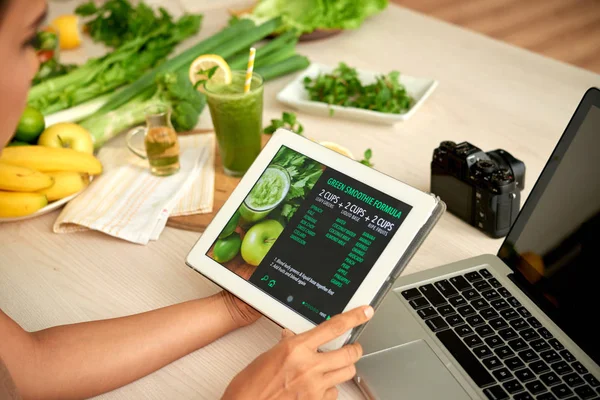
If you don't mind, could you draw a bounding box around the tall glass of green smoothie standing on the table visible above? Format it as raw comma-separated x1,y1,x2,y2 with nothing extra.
205,71,263,176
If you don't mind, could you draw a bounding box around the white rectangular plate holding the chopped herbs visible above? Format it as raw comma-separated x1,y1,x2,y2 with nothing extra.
277,63,438,125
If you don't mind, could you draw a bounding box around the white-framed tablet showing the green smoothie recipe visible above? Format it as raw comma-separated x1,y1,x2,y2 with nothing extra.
186,129,445,350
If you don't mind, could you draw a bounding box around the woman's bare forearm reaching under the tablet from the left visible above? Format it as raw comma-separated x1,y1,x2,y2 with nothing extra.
0,292,259,400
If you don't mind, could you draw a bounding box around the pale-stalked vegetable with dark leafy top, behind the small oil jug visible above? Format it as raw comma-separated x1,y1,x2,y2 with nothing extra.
80,72,206,147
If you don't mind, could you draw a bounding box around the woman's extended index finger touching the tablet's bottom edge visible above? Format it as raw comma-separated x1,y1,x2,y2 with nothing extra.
302,306,374,349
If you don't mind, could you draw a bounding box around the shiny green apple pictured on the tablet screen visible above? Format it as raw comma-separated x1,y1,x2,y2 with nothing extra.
242,219,283,266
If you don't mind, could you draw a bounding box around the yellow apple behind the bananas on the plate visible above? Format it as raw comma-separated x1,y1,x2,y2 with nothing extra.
38,122,94,154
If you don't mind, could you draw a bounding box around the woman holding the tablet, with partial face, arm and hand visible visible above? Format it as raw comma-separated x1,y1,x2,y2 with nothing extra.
0,0,373,400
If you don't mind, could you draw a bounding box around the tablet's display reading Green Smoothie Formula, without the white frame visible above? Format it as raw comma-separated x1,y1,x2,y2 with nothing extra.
207,146,412,324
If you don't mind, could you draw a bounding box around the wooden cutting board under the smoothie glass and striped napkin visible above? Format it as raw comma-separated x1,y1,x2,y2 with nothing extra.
167,131,271,232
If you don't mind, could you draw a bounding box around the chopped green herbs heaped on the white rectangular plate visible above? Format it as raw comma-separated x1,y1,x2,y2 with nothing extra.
304,62,413,114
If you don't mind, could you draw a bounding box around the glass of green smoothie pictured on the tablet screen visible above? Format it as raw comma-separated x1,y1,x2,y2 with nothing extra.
240,165,291,222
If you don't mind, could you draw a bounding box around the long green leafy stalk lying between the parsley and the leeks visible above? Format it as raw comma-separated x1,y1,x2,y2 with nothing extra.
28,16,200,115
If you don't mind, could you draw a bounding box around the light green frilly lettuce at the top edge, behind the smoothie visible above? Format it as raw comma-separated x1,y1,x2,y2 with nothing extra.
241,0,388,34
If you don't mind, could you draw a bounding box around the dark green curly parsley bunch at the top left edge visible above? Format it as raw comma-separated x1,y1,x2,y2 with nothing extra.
75,0,202,48
